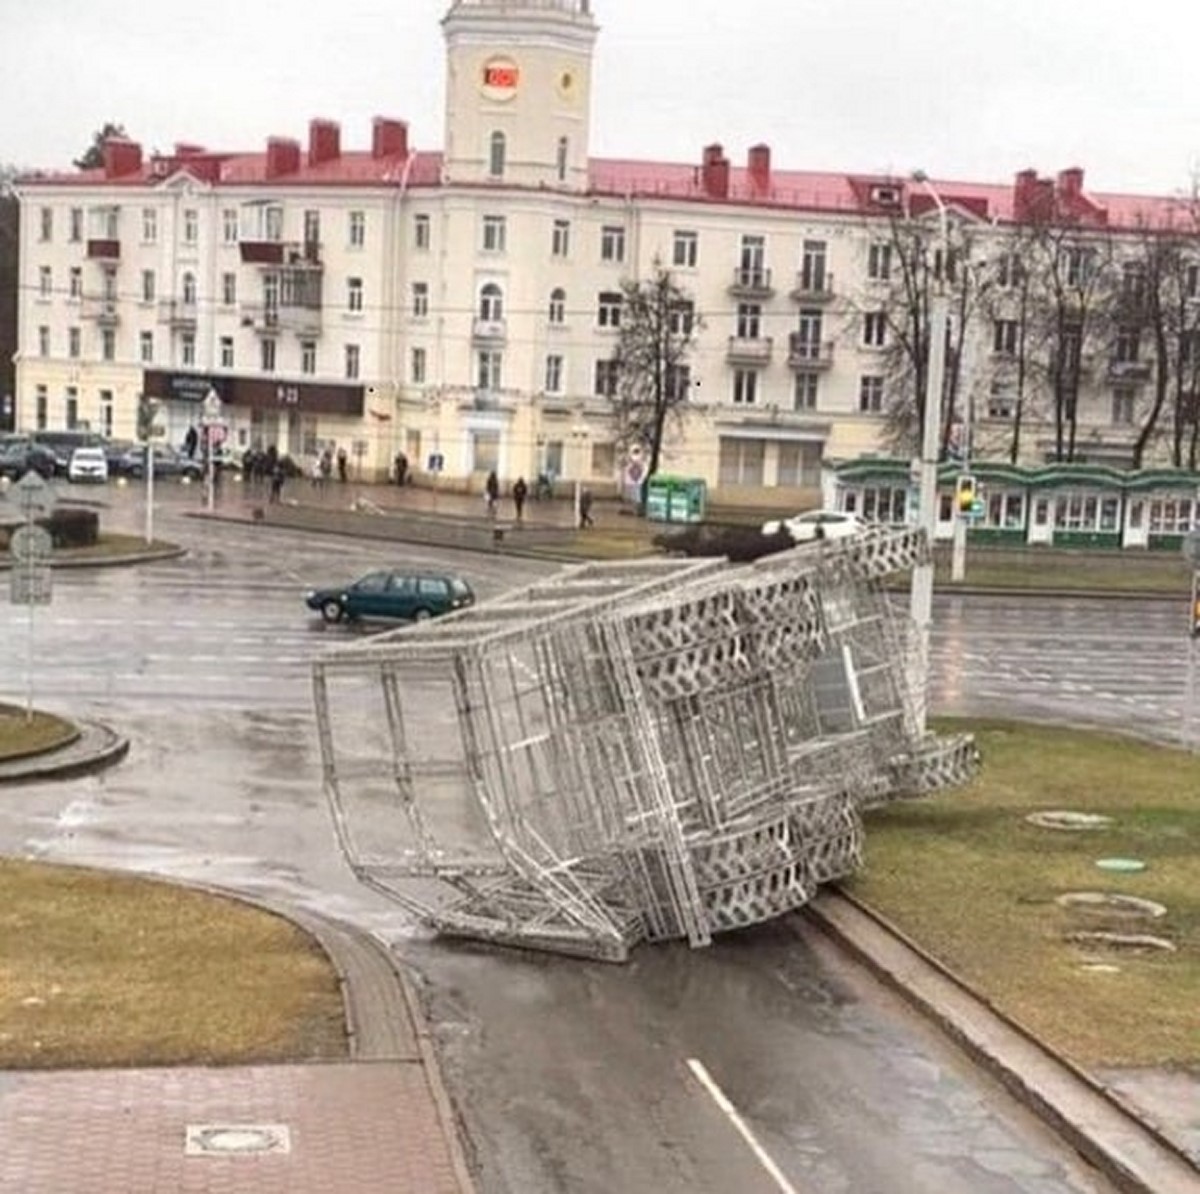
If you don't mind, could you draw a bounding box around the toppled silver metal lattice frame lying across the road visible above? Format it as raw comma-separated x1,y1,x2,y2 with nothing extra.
313,529,977,961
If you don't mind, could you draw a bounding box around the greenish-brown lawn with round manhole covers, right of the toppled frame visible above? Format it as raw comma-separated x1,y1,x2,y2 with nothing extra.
846,721,1200,1066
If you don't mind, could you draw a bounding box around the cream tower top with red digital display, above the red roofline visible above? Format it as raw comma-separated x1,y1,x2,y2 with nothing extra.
442,0,598,191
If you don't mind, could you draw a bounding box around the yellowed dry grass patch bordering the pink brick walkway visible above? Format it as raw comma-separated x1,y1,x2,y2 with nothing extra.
0,860,347,1069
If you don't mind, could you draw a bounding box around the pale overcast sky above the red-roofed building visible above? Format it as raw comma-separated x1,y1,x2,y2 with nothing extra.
0,0,1200,194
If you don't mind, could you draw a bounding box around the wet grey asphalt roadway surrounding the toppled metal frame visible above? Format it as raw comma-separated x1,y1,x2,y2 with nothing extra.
0,494,1186,1194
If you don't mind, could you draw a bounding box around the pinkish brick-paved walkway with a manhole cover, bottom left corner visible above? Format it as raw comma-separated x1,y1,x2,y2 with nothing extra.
0,1061,460,1194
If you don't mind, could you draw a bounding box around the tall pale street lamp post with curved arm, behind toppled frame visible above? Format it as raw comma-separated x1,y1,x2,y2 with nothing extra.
910,172,950,732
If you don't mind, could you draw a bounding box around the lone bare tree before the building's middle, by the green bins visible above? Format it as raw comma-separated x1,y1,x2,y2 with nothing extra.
608,260,703,510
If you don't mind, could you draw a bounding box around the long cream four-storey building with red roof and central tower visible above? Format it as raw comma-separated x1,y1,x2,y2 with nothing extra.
9,0,1200,504
